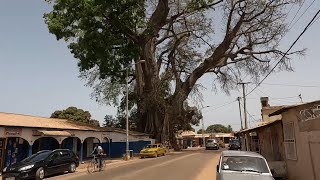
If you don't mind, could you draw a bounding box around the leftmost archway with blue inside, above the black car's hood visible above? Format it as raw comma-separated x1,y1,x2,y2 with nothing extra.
1,137,29,166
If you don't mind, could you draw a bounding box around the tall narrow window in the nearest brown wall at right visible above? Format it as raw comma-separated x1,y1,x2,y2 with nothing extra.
283,122,297,160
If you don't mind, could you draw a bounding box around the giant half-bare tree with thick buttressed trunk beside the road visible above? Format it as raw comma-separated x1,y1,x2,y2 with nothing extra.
44,0,303,146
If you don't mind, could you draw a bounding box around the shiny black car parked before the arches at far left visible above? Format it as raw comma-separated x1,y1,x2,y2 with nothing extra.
2,149,79,180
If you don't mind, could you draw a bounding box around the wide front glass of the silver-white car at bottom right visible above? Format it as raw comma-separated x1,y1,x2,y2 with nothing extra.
221,156,269,173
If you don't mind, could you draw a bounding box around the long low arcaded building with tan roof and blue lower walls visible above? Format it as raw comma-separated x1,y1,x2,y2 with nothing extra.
0,113,154,168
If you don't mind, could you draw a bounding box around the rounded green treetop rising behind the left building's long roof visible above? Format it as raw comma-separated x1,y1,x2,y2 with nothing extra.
50,106,100,126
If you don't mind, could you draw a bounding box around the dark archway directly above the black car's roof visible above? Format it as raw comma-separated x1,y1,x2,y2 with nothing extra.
32,137,60,154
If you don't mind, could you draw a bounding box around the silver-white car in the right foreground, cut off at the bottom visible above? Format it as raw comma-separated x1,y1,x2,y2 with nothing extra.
216,151,274,180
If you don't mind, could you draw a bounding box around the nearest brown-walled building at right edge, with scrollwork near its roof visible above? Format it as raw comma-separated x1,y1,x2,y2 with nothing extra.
270,101,320,180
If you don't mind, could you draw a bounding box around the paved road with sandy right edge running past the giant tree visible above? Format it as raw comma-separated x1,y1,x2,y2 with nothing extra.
48,150,220,180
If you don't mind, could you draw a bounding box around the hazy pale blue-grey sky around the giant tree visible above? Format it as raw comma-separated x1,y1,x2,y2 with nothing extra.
0,0,320,130
